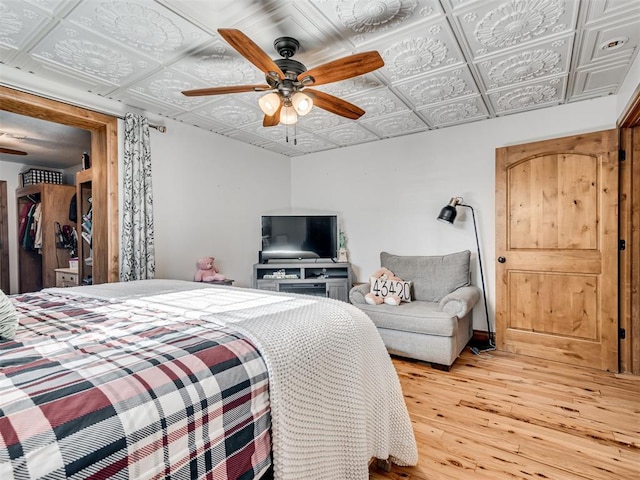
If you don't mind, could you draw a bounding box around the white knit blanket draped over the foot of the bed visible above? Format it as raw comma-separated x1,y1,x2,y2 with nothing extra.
121,287,418,480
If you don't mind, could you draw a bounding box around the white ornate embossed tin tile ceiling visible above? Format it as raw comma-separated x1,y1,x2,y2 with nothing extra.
0,0,640,156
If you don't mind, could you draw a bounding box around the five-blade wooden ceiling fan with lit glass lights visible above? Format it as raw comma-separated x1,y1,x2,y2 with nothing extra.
182,28,384,127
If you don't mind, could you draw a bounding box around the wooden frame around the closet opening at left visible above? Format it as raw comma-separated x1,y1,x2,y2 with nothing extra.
0,86,119,283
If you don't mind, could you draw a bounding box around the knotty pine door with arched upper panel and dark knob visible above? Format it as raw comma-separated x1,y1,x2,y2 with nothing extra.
496,130,618,371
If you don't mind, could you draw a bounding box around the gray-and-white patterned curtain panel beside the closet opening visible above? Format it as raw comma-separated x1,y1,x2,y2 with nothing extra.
120,113,156,282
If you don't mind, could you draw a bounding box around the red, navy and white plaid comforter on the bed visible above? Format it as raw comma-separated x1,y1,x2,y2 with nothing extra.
0,292,270,480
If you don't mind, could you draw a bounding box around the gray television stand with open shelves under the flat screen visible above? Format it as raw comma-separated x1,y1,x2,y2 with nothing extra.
253,259,352,302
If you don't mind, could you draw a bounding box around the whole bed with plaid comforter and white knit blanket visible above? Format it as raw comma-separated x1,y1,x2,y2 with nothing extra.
0,280,417,480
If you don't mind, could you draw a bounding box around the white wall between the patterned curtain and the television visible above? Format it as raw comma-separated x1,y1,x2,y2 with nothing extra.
145,119,291,287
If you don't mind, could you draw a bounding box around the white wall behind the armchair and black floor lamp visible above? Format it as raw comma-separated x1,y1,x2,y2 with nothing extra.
291,97,617,330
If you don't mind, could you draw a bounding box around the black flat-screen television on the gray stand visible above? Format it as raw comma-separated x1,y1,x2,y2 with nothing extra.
262,215,338,262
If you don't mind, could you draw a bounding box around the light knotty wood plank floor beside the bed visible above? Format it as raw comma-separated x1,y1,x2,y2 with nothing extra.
369,350,640,480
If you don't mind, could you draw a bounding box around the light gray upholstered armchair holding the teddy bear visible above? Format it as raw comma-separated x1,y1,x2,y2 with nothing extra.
349,250,481,370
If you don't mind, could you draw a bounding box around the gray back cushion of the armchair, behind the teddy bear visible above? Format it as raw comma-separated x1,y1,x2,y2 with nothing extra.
380,250,471,302
